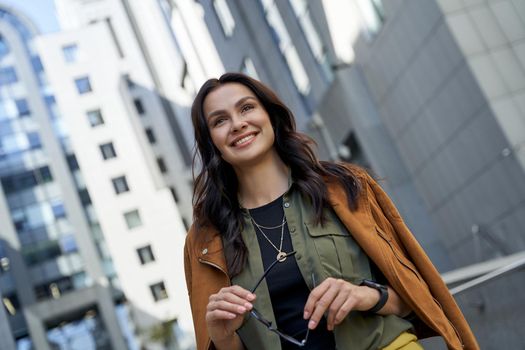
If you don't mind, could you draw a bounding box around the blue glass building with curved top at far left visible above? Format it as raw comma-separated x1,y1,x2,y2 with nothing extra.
0,6,129,349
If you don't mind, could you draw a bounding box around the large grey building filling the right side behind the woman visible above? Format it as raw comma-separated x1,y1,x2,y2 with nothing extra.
199,0,525,348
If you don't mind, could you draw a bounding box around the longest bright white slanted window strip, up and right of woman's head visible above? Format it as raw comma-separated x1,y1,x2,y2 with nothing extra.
259,0,310,95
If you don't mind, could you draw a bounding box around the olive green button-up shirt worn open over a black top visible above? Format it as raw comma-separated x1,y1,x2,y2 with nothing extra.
232,187,412,350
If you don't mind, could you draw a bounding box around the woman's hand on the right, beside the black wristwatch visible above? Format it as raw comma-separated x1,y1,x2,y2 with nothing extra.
304,277,380,330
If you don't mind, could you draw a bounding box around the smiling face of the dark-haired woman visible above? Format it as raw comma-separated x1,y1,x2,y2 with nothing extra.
203,83,275,168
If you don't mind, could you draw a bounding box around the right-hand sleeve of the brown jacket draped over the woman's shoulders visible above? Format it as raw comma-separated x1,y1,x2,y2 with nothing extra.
366,174,479,349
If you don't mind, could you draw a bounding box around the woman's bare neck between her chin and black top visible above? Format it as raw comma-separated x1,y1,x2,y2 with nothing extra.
235,153,290,209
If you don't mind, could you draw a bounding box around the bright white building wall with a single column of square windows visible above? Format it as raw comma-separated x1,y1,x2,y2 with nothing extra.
38,22,192,340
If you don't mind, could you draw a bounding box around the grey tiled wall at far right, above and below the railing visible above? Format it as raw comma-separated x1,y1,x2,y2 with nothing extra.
348,0,525,349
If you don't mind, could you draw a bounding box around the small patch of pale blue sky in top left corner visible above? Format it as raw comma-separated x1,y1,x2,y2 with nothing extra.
0,0,59,33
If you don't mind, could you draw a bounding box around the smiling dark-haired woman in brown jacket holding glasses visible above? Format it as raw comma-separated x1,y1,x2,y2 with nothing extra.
185,73,478,350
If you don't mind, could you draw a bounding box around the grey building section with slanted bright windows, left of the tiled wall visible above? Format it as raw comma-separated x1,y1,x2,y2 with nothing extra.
196,0,453,270
